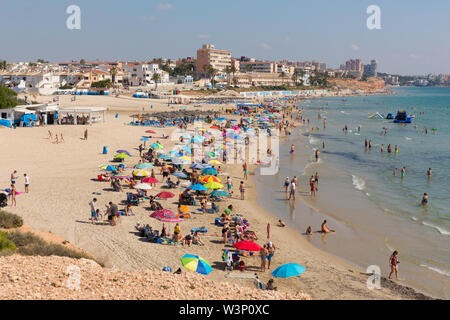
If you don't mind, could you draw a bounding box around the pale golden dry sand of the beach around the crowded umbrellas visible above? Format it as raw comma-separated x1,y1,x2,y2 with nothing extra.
0,96,425,299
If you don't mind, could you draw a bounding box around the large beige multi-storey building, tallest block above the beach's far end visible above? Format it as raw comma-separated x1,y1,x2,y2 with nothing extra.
197,44,231,76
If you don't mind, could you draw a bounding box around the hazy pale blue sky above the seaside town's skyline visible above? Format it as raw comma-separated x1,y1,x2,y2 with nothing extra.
0,0,450,74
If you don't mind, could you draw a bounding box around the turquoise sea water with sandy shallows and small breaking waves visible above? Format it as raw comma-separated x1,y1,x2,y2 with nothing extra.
256,88,450,297
